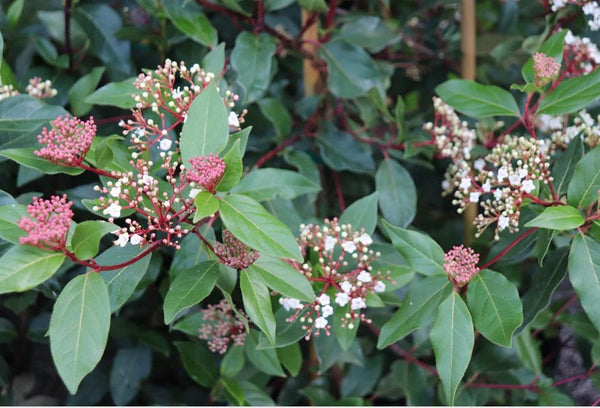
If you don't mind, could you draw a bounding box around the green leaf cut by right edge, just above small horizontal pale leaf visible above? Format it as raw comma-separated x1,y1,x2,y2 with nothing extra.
567,146,600,209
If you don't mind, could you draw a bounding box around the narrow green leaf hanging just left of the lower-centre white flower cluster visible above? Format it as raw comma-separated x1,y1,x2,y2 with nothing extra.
240,271,276,344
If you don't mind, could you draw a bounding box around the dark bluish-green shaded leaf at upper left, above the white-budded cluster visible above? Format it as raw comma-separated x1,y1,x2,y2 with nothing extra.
73,3,133,79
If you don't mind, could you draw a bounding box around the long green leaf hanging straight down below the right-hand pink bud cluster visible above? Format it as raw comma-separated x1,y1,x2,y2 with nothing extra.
430,292,475,405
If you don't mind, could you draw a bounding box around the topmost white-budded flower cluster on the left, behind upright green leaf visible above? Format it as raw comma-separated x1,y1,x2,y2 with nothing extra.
120,59,243,151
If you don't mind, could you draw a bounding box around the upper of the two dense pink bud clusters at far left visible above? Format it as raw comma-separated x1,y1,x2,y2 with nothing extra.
34,115,96,167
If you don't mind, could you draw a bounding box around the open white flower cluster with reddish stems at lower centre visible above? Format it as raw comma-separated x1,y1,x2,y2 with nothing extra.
279,218,390,340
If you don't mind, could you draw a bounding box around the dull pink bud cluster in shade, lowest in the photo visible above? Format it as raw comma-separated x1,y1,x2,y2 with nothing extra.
198,299,248,354
